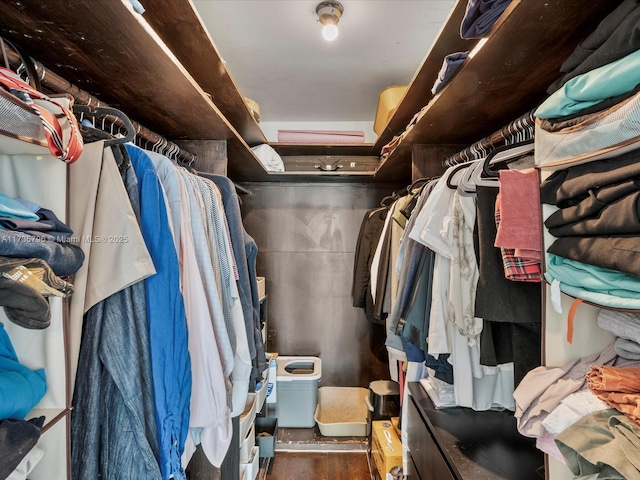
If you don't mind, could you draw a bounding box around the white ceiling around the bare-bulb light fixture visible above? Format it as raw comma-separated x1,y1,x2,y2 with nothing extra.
193,0,455,122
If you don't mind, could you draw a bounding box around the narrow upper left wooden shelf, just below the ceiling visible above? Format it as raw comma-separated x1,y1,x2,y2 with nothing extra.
143,0,267,147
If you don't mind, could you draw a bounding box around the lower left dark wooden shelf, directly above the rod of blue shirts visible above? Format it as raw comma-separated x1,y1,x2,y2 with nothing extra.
0,0,267,182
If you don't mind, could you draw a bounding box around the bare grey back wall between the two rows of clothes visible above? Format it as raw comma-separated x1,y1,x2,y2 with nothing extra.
242,183,400,387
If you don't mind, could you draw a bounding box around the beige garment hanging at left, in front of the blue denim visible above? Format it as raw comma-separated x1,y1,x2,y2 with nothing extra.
69,138,156,384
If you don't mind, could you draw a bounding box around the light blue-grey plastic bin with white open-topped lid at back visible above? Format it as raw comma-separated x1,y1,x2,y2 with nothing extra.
275,357,322,428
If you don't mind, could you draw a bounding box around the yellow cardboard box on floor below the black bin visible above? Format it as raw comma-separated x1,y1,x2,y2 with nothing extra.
371,420,403,480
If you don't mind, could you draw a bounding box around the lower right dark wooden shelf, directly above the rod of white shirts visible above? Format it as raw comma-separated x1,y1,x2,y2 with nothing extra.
376,0,619,182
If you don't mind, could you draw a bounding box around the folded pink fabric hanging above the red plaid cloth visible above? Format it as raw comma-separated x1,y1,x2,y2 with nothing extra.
494,168,542,251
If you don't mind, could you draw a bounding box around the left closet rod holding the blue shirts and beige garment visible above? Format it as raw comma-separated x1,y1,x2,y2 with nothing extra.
4,43,197,164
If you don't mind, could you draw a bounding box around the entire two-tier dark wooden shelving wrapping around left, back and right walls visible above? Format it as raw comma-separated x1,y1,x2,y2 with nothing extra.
0,0,619,183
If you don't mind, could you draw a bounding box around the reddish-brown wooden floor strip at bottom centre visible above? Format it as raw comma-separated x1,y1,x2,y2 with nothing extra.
266,451,371,480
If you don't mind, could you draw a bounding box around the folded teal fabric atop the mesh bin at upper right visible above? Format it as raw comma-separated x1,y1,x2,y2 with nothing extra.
534,50,640,118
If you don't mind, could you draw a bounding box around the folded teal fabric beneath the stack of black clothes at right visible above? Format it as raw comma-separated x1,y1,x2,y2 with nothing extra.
545,253,640,310
